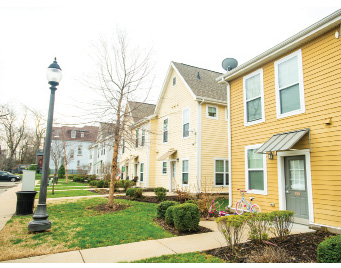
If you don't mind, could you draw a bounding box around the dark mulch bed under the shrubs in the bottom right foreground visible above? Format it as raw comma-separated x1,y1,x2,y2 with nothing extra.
206,231,335,263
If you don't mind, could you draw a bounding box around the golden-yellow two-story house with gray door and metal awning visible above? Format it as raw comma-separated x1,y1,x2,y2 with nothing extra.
217,10,341,232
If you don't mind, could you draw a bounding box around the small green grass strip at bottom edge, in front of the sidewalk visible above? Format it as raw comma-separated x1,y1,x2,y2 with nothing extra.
129,252,224,263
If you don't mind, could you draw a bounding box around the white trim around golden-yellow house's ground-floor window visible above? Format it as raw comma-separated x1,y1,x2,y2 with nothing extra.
245,144,268,195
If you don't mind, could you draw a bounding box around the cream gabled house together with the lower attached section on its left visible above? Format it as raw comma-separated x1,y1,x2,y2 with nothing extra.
120,62,229,193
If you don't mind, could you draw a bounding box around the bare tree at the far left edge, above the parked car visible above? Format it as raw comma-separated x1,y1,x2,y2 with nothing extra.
0,105,27,170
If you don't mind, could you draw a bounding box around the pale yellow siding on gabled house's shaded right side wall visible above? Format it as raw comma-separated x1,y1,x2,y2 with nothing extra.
201,102,228,193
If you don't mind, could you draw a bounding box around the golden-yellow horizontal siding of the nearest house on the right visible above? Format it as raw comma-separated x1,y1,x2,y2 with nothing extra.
230,29,341,227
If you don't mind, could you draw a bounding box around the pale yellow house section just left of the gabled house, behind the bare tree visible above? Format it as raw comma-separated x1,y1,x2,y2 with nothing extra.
119,101,156,187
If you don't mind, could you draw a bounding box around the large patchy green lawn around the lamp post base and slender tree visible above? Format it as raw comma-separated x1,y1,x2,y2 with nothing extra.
0,198,173,261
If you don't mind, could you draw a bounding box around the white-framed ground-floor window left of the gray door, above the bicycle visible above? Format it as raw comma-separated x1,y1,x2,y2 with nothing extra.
245,144,267,194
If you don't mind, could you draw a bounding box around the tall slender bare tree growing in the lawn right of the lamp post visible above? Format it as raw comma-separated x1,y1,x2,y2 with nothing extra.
86,31,153,207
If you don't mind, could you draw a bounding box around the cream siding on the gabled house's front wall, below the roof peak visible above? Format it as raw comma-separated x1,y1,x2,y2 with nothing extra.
155,70,197,191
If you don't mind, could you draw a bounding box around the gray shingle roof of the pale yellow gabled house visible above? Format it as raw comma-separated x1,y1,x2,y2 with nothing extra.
173,62,226,101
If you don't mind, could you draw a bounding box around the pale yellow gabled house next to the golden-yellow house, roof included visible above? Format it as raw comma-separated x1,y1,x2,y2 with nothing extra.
150,62,229,193
